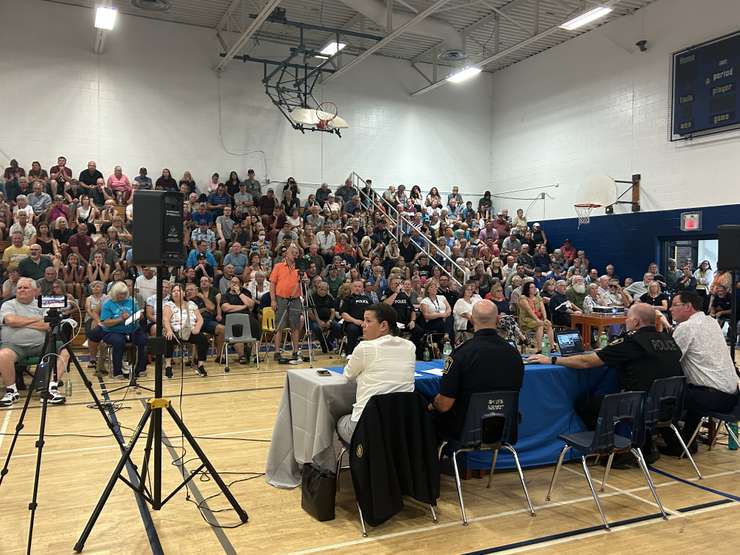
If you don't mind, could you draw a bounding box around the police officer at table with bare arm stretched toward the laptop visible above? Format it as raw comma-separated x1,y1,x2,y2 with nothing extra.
529,303,683,468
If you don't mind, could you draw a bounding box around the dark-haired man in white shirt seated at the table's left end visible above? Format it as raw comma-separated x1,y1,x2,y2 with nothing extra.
337,303,416,443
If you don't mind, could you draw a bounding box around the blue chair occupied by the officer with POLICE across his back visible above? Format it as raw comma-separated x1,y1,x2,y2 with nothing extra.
644,376,702,480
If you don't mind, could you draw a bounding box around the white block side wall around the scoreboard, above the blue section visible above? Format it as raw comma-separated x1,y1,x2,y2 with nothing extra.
491,0,740,220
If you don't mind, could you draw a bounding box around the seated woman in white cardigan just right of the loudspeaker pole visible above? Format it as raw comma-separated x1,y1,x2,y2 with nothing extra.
162,284,208,378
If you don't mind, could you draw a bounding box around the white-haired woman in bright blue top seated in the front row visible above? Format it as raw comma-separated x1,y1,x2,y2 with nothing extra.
100,281,147,378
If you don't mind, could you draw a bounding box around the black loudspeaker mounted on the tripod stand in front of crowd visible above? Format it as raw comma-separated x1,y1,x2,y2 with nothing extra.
132,191,185,266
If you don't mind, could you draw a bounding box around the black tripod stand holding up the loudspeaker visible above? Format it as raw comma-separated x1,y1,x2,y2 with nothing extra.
74,266,249,553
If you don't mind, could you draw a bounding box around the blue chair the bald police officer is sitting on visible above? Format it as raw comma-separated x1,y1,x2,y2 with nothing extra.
439,391,535,526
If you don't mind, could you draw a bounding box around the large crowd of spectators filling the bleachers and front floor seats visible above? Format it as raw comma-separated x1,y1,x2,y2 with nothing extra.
0,156,731,414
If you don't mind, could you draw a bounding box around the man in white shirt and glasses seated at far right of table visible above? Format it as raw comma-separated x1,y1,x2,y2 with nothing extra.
668,291,738,455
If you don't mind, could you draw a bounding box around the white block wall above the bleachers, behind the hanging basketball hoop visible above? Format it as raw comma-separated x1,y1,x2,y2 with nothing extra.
0,0,491,190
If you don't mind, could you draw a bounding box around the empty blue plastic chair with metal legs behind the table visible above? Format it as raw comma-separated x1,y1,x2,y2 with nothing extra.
546,391,668,530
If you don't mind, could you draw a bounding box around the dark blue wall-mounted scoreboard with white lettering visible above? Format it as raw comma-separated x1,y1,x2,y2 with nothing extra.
671,31,740,140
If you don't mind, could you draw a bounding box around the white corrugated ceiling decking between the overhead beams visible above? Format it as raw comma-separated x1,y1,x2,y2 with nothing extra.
47,0,657,71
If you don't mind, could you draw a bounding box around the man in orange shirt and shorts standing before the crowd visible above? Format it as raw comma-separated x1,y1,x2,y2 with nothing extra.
270,244,303,360
